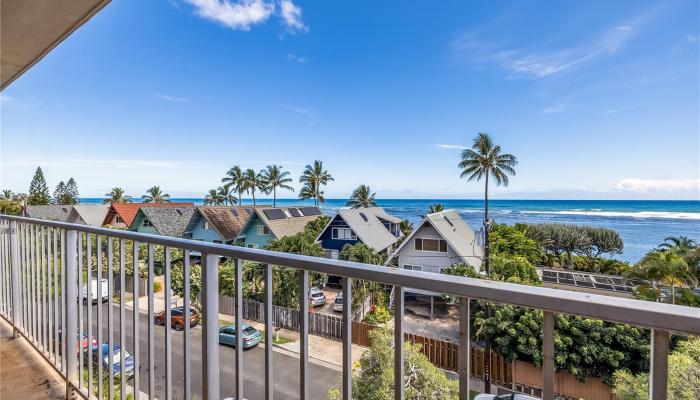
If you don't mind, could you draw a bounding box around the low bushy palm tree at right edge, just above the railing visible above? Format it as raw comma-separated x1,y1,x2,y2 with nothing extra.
627,251,698,304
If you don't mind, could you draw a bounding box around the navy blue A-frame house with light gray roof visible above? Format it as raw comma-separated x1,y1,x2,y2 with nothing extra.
317,207,401,259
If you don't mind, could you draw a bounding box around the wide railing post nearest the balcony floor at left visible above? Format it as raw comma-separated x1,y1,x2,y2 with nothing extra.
61,230,79,399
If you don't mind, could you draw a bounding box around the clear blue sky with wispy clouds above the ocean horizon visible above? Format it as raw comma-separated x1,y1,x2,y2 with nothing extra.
0,0,700,199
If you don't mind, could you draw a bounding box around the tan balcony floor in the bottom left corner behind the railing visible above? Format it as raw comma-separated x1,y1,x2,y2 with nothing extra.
0,318,66,400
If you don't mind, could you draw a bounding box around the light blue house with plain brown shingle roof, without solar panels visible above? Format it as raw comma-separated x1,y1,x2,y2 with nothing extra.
184,206,253,244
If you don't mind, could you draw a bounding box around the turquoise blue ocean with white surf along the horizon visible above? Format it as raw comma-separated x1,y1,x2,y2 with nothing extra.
81,198,700,262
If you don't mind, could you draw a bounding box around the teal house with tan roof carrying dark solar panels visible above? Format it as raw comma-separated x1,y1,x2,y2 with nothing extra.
236,207,323,248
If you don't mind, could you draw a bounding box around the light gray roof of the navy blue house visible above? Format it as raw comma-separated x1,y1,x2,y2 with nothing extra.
334,207,401,252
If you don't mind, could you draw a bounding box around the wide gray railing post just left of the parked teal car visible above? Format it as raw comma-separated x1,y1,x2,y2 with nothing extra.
202,254,219,400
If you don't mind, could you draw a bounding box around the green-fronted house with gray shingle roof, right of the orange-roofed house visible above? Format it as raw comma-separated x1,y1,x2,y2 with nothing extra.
129,206,194,237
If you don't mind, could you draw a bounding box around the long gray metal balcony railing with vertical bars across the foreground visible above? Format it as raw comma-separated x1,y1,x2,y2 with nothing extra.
0,215,700,400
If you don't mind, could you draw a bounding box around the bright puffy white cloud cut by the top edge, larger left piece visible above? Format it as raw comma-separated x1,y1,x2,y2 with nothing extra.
187,0,275,31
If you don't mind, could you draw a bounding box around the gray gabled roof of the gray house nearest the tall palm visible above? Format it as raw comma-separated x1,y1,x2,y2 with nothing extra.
387,210,484,270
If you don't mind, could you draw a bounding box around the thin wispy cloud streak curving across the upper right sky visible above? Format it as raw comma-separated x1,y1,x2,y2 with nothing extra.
452,10,656,79
